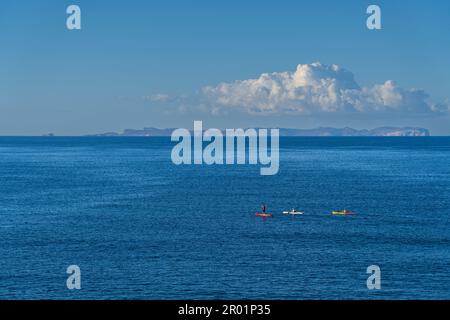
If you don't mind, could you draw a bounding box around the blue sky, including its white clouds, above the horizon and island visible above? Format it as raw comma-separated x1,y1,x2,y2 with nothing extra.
0,0,450,135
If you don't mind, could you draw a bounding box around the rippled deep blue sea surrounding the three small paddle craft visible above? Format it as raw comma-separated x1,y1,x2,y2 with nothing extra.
0,137,450,299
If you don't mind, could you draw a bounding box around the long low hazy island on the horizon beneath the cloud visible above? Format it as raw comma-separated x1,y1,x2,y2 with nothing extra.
91,127,430,137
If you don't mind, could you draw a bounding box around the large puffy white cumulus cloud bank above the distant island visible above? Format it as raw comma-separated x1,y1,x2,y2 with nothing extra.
202,62,449,115
